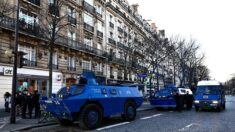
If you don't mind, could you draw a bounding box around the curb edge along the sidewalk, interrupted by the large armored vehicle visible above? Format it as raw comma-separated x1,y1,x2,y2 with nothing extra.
10,107,155,132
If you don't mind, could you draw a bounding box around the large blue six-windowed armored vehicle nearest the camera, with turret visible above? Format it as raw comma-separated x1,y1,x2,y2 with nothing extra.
40,72,143,129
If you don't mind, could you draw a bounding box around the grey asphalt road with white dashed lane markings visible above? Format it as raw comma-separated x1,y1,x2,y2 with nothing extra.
25,96,235,132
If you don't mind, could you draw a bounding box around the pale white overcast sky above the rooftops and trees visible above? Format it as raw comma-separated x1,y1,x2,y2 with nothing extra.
128,0,235,82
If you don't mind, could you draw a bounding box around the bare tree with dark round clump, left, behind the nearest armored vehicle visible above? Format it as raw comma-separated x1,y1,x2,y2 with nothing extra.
39,0,72,97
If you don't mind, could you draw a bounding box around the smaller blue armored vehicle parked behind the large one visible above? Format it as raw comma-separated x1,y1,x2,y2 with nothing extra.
149,84,177,109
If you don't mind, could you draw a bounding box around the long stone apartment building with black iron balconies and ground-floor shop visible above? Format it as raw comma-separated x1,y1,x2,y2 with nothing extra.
0,0,172,104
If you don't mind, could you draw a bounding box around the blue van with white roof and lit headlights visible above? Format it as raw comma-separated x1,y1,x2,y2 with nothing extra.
194,80,226,111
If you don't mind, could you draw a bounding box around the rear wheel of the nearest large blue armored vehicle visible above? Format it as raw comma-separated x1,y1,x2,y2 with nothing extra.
122,101,136,121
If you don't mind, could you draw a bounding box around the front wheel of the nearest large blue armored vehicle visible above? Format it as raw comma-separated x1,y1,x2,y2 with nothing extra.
79,104,102,130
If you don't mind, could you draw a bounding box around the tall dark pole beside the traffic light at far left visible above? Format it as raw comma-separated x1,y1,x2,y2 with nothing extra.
10,0,19,124
